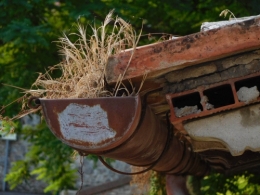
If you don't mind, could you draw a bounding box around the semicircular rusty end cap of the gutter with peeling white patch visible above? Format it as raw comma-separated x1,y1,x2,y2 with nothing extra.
40,97,141,152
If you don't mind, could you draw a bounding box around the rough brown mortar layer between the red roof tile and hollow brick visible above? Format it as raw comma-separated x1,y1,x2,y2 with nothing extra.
163,50,260,93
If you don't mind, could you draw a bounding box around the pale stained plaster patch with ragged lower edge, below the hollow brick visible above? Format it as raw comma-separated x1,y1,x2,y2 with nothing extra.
184,104,260,156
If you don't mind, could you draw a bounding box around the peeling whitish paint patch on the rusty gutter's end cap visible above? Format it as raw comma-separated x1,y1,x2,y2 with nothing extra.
58,103,116,145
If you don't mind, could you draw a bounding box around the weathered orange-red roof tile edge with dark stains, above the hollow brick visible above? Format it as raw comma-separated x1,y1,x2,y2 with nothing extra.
106,16,260,83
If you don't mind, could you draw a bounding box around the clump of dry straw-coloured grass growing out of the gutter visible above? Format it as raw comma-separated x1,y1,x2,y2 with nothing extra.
0,11,141,120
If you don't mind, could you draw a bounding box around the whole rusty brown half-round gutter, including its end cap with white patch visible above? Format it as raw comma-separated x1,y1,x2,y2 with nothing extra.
40,96,209,175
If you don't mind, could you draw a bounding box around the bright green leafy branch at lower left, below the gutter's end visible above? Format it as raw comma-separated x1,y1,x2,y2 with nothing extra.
6,123,77,193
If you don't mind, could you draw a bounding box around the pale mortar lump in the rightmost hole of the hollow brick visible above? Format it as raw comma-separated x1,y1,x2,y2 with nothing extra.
237,86,259,104
